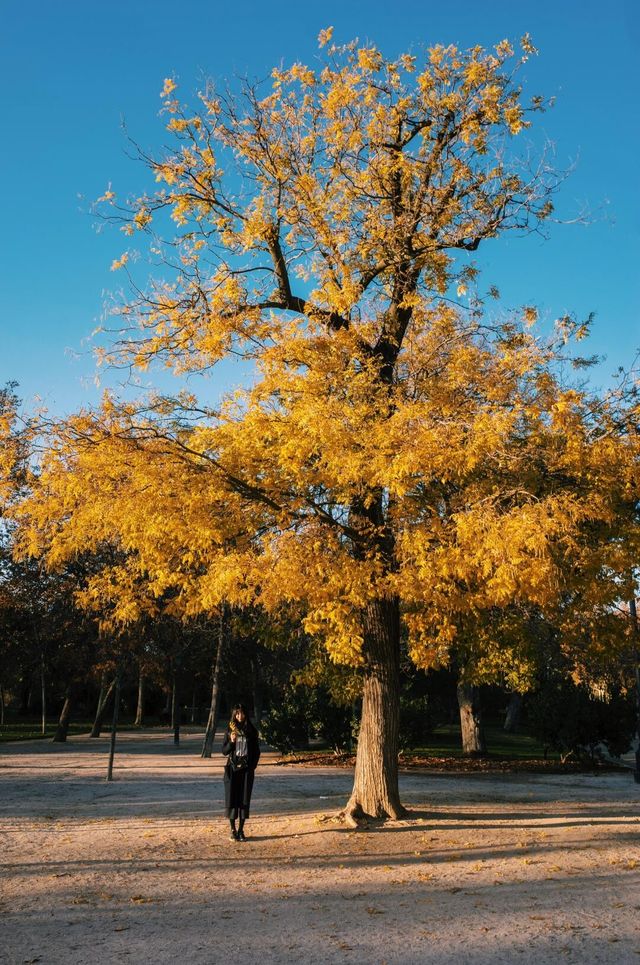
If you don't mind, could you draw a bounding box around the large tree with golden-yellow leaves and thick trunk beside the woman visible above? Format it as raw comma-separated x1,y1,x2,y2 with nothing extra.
11,32,637,820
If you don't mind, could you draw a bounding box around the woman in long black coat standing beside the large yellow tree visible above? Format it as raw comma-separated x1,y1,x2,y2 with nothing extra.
222,704,260,841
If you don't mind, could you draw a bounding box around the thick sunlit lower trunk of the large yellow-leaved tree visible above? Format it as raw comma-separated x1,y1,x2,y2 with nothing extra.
345,598,406,827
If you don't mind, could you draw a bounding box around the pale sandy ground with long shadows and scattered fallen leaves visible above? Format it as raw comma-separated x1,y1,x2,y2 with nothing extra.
0,733,640,965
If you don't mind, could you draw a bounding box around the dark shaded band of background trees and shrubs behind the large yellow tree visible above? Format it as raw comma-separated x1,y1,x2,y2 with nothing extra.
0,529,638,761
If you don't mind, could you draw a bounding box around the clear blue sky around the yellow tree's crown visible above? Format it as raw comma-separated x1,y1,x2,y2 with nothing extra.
0,0,640,413
